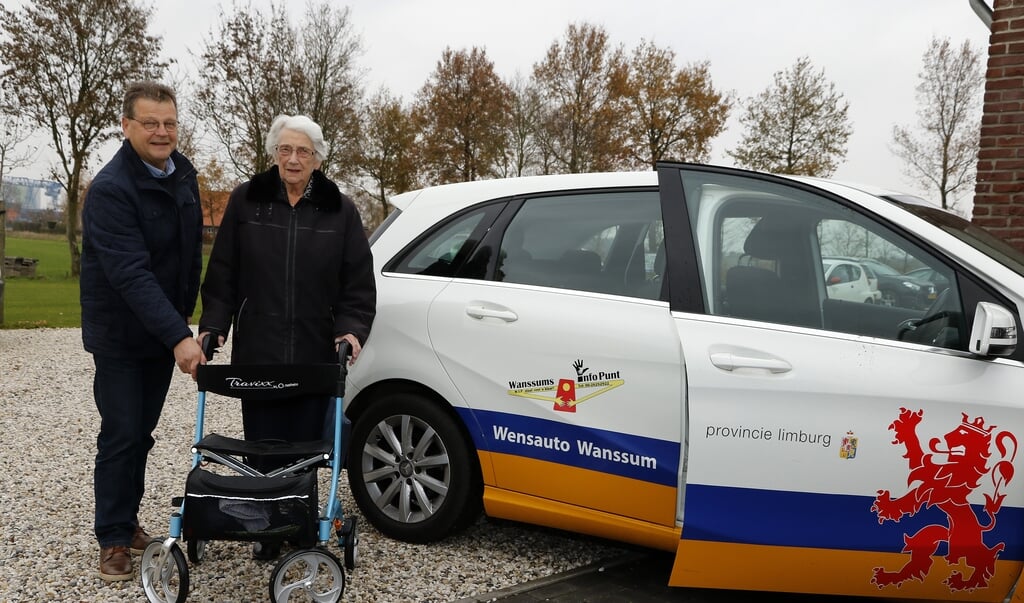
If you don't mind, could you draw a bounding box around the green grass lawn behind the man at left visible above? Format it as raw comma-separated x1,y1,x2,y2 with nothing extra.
0,230,209,329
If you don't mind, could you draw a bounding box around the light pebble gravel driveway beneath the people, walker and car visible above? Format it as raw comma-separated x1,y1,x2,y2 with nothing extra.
0,329,623,603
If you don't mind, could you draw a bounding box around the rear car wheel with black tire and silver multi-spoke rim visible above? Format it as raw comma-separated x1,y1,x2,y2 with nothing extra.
347,392,482,544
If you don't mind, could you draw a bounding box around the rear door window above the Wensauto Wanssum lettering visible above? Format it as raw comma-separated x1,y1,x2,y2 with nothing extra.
495,191,665,299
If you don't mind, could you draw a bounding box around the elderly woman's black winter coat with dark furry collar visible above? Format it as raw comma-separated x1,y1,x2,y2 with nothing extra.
200,166,377,364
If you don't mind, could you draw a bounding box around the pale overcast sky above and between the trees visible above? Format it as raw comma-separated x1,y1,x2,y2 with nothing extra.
3,0,991,204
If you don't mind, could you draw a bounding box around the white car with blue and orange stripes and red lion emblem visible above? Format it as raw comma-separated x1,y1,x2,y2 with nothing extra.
346,164,1024,601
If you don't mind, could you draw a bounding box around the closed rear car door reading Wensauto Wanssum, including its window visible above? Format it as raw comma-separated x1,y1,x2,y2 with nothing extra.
428,188,685,544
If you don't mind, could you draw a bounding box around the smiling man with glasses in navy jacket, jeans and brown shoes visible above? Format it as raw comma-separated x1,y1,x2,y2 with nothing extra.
80,82,203,582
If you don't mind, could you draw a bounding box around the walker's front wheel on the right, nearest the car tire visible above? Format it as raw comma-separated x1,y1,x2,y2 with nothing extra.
270,549,345,603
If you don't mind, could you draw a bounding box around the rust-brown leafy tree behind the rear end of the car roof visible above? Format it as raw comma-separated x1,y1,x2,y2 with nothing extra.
413,47,512,183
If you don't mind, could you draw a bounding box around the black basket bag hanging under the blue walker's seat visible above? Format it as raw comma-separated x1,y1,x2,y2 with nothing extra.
182,467,319,546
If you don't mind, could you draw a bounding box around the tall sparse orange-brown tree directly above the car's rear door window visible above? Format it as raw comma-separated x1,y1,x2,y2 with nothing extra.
534,24,625,173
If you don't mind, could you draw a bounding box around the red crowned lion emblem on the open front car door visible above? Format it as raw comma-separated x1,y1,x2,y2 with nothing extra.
871,408,1017,591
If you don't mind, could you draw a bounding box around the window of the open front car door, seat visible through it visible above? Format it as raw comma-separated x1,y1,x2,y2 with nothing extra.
683,172,966,348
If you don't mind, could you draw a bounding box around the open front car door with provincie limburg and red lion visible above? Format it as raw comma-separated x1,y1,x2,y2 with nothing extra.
659,161,1024,601
